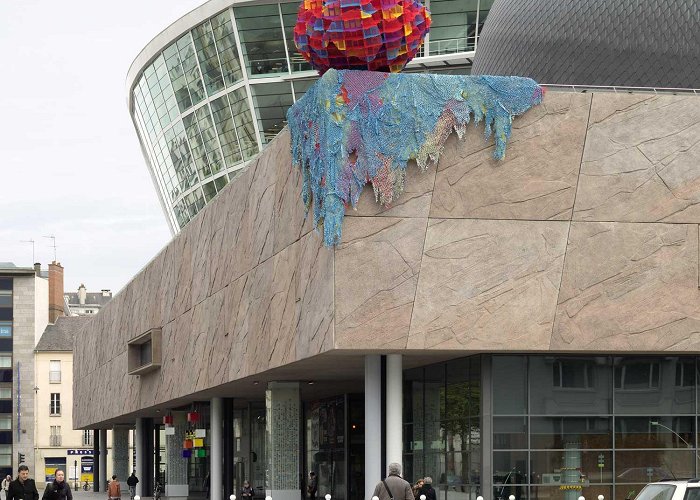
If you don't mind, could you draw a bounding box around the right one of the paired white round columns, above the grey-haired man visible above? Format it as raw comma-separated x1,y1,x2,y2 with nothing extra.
386,354,403,465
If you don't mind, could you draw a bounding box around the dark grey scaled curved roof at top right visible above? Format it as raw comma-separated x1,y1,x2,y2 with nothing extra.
472,0,700,88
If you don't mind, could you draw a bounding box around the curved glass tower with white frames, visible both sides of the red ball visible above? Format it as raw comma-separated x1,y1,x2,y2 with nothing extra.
127,0,493,233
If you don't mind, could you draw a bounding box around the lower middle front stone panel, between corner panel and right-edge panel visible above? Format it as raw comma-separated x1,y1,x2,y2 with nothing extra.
408,219,569,351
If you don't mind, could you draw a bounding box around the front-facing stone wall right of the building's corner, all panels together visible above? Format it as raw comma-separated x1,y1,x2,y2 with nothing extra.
335,92,700,352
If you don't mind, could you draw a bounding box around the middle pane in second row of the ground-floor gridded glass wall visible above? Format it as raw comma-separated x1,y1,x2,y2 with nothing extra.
530,417,612,450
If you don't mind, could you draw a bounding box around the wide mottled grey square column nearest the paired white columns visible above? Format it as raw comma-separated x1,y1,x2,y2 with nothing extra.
265,382,301,500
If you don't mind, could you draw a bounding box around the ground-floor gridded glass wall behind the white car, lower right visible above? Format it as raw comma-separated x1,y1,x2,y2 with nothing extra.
492,356,697,500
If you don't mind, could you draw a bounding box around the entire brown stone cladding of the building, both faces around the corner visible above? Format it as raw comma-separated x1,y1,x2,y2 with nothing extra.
74,91,700,427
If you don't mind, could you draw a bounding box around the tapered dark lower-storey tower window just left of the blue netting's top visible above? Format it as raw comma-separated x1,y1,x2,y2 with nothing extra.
250,82,293,144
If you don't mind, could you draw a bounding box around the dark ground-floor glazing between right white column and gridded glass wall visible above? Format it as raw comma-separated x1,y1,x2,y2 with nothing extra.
403,356,481,500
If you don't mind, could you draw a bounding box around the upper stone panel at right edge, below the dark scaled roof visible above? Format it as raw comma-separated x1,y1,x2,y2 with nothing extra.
574,93,700,223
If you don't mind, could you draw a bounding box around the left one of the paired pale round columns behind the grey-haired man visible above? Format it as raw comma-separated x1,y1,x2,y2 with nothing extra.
364,354,383,498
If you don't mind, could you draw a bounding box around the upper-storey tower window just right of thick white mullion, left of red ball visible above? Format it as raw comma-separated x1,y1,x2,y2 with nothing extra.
233,4,288,78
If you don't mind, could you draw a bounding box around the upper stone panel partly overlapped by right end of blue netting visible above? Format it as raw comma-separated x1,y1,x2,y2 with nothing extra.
430,92,591,220
